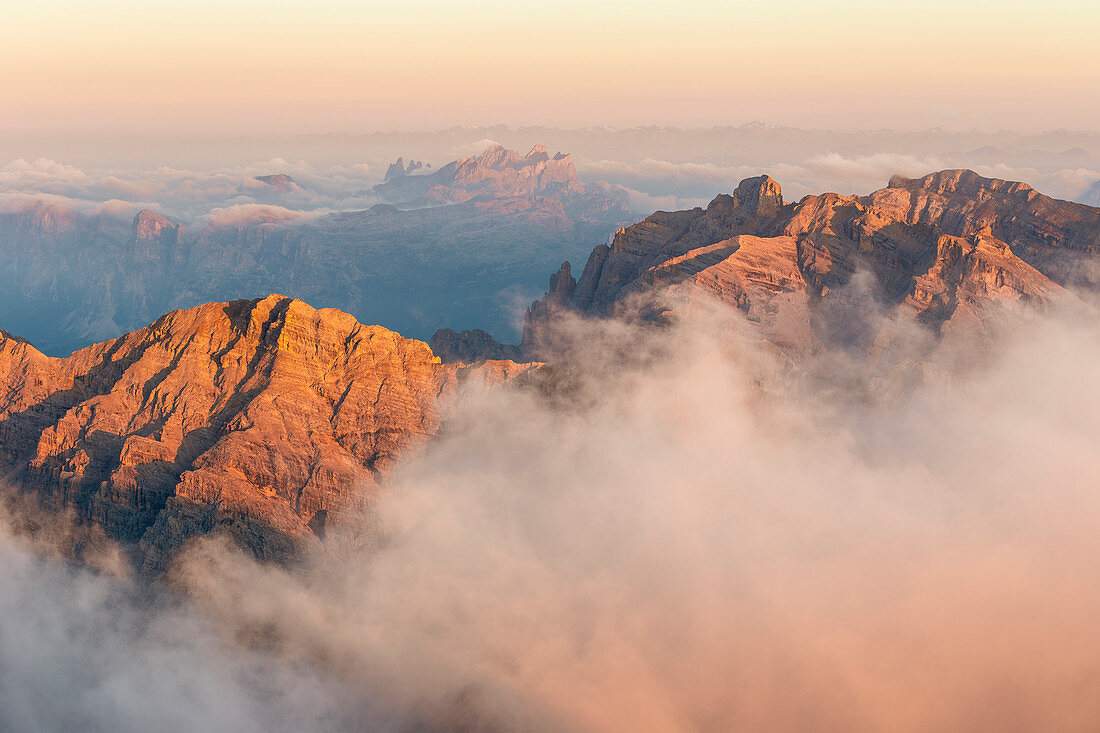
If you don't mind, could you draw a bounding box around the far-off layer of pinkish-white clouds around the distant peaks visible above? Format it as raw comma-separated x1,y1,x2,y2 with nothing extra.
0,128,1100,227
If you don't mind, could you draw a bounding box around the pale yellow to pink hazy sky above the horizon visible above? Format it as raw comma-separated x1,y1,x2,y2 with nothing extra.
0,0,1100,133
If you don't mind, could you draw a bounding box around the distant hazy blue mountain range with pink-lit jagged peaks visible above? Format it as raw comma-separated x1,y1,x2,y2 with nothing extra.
0,149,629,355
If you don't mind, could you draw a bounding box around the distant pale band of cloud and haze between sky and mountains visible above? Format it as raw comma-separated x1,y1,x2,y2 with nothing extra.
8,124,1100,226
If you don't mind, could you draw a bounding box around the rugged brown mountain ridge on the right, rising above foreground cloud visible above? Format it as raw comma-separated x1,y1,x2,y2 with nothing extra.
440,171,1100,358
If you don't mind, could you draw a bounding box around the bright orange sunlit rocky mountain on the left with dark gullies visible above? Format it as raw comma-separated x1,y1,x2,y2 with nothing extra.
0,295,527,573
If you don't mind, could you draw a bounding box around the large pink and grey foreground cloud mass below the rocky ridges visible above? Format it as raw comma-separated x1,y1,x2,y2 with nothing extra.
0,288,1100,732
